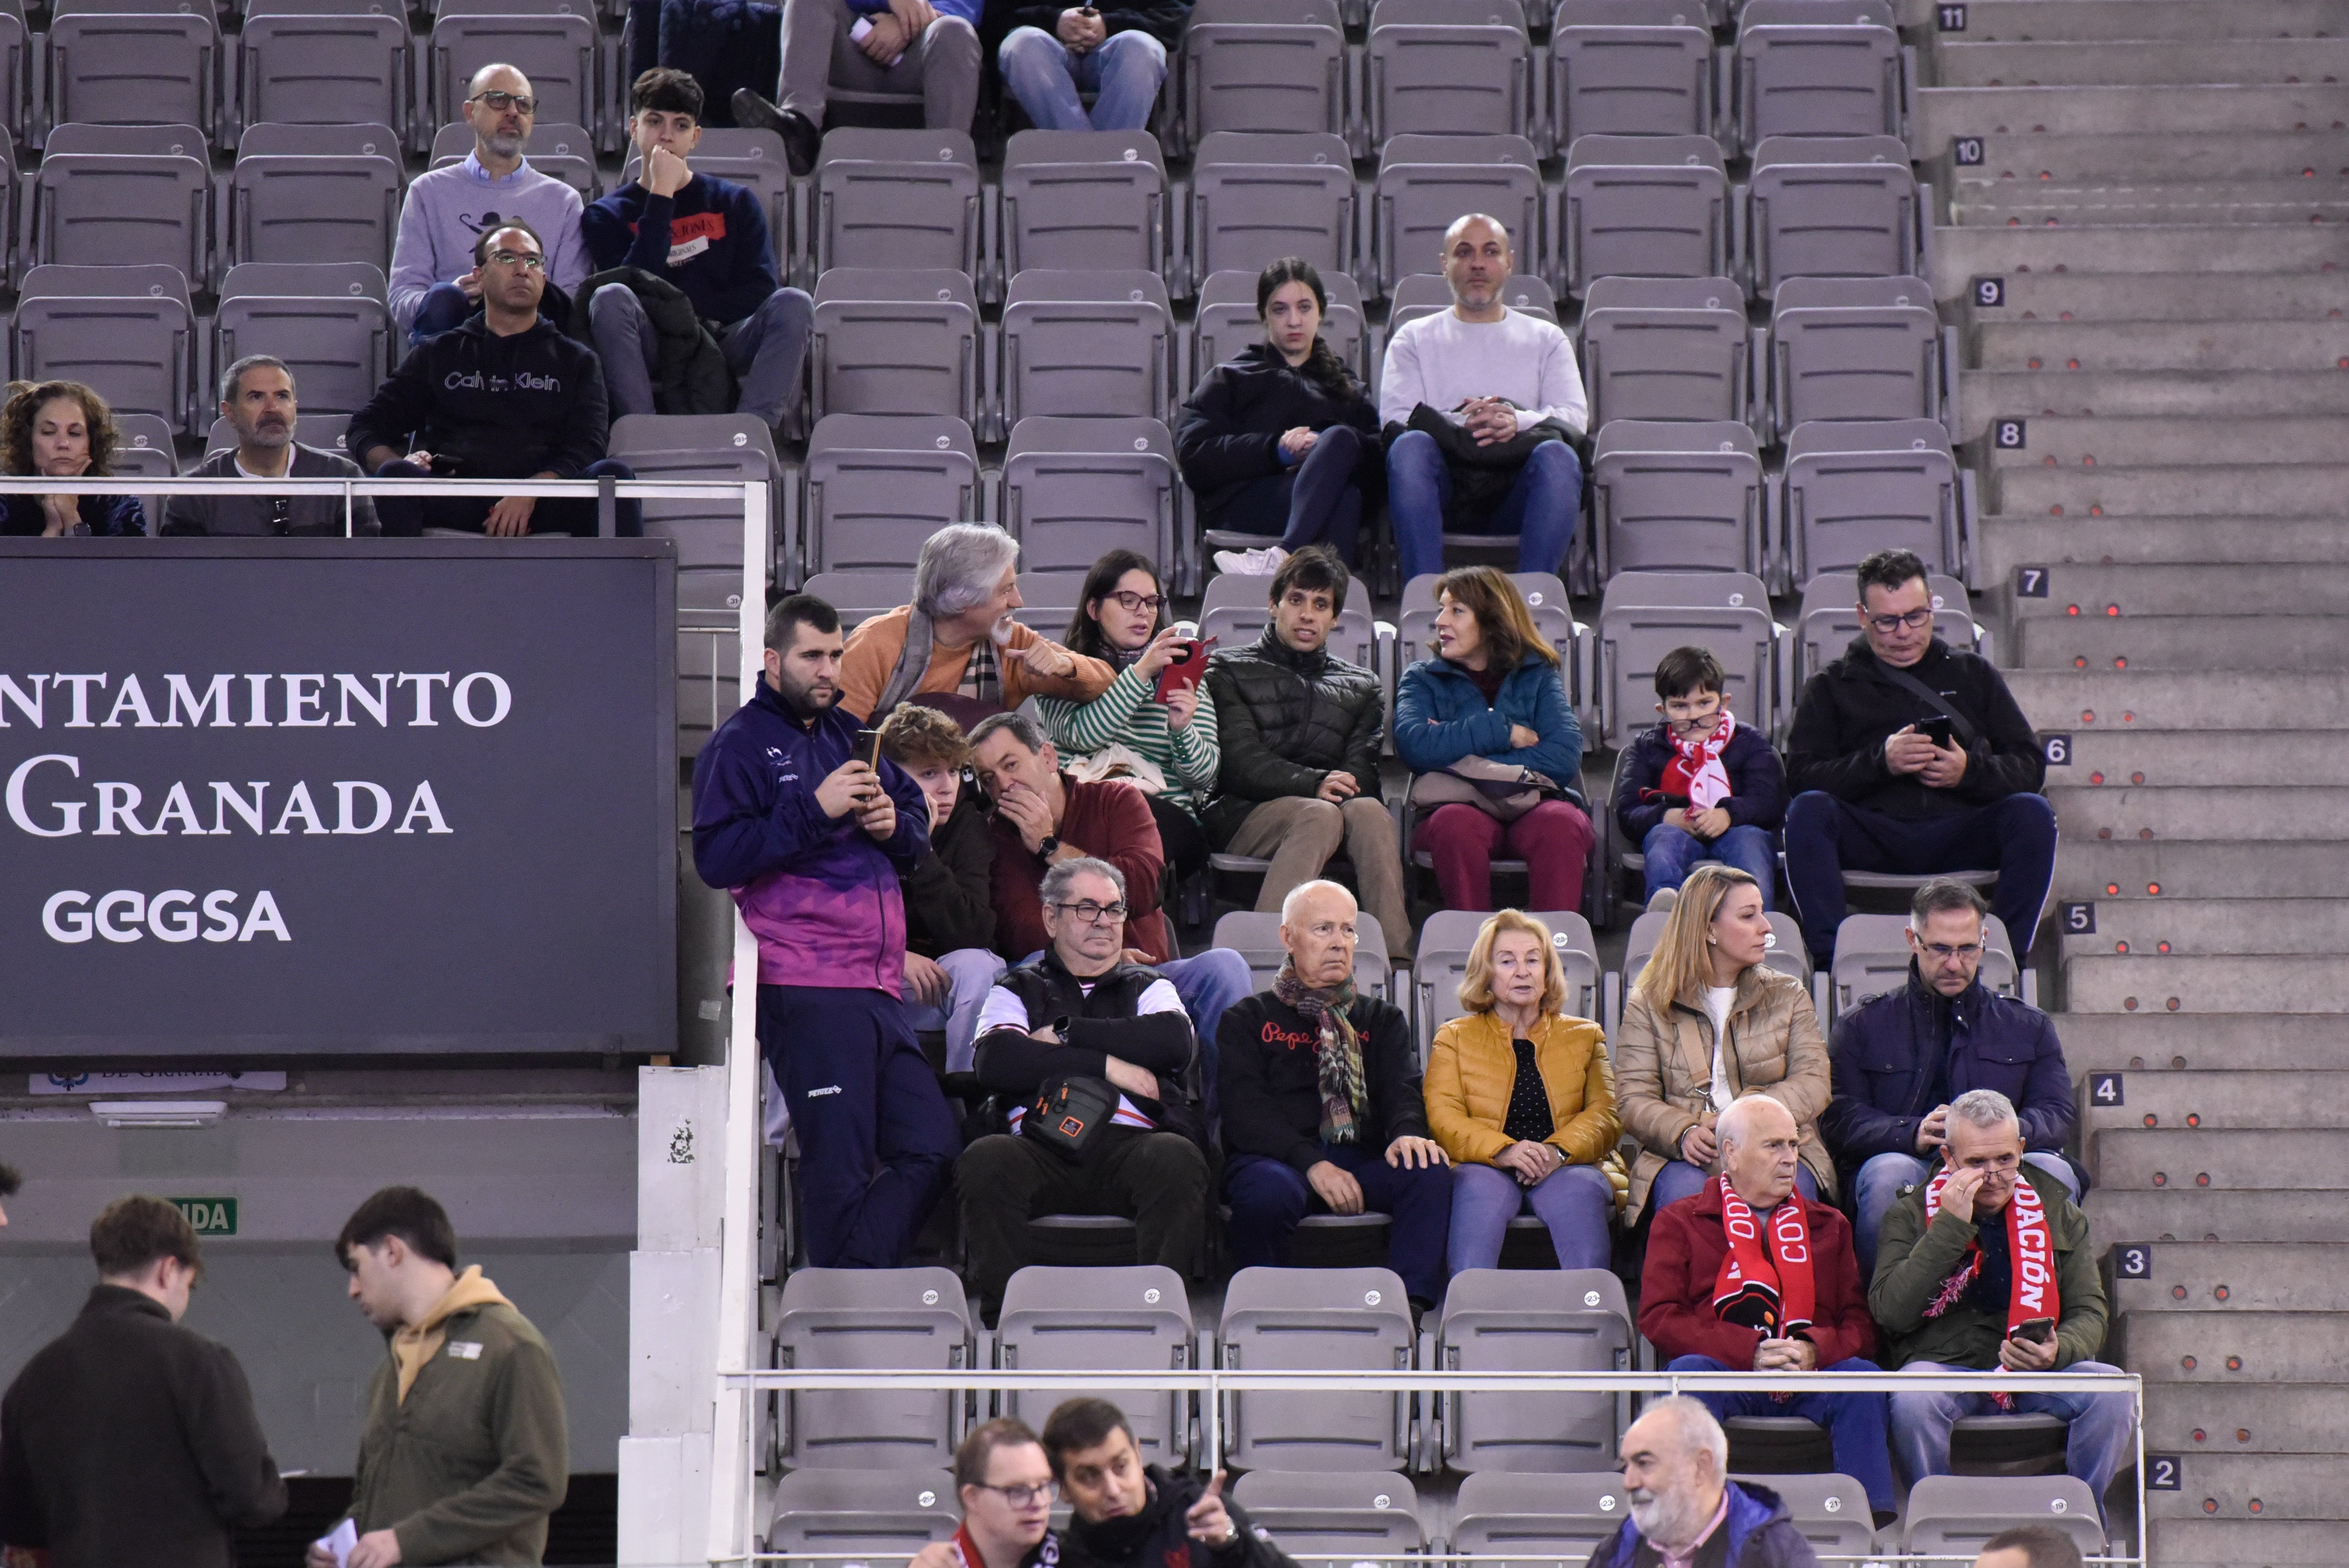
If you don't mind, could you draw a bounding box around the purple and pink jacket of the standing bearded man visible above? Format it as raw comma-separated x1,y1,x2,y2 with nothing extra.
693,681,930,998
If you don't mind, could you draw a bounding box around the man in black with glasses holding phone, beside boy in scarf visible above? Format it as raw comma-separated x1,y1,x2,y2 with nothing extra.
1785,549,2056,969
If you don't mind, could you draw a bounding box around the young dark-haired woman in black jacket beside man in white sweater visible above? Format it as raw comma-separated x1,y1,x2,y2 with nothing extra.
1175,256,1386,578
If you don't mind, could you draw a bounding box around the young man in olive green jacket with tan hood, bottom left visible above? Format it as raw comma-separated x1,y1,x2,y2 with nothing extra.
308,1188,571,1568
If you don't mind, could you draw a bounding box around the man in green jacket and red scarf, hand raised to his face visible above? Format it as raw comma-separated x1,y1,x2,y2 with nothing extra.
1867,1089,2135,1507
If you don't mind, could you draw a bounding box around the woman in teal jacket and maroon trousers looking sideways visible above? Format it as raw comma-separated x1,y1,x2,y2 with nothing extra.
1395,566,1593,911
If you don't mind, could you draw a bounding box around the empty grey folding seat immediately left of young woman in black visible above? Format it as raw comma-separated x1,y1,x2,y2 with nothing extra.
1003,415,1182,578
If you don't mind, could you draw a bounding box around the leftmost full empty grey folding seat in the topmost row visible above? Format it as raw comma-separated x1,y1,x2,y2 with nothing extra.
47,0,221,136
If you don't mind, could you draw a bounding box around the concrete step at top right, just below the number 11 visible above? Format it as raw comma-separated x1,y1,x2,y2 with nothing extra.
1933,36,2349,89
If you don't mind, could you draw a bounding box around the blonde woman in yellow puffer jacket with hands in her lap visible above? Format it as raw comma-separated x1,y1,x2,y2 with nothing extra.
1426,908,1623,1275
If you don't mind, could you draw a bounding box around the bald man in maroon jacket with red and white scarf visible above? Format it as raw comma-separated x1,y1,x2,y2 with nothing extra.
1640,1094,1893,1523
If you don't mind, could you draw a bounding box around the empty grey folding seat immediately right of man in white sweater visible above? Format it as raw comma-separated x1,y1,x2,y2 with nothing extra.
1590,420,1767,578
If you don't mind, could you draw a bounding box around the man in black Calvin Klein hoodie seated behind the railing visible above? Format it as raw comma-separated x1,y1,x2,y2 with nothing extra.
348,223,643,538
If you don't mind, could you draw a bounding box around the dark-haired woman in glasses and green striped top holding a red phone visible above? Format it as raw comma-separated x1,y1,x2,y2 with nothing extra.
1036,549,1224,878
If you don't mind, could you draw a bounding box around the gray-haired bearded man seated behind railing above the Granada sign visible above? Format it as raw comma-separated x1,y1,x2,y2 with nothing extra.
162,354,380,538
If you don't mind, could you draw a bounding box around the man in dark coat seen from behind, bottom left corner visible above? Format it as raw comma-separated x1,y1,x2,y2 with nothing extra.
0,1197,287,1568
